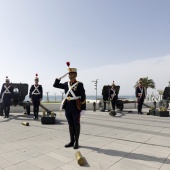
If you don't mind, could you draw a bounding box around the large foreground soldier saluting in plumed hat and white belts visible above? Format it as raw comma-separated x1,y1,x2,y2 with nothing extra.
53,62,86,149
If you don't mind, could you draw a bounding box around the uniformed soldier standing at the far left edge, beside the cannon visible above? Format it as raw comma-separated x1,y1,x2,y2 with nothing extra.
0,76,13,118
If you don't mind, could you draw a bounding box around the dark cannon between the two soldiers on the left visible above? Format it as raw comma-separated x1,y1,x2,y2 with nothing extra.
0,83,51,115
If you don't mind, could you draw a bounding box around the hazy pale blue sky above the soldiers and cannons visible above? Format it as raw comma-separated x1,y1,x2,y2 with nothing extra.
0,0,170,95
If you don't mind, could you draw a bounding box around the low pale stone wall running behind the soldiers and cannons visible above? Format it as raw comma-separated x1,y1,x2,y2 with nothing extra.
10,102,155,113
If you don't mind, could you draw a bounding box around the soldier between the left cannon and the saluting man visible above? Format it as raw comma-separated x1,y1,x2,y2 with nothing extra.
29,74,43,120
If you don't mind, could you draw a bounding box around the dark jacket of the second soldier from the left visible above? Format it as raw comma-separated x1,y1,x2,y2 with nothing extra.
29,84,43,100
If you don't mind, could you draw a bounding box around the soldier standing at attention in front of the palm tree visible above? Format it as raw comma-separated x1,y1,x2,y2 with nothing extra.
135,81,145,114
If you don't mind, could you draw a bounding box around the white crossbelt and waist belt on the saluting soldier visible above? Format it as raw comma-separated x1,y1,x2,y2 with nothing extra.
60,81,80,111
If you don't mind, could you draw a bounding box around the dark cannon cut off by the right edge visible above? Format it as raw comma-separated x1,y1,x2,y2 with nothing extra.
159,86,170,108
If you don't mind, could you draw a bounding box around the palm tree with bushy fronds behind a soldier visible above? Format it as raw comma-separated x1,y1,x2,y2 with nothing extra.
135,77,155,95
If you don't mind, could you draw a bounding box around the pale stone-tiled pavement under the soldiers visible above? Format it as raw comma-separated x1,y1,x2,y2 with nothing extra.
0,109,170,170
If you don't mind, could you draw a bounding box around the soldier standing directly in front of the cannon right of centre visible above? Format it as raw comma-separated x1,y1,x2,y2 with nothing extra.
109,81,118,111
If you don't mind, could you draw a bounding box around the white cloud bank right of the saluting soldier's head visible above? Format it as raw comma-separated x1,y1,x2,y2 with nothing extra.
78,55,170,95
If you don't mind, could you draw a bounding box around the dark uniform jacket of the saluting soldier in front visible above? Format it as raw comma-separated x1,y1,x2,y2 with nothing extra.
53,79,86,110
